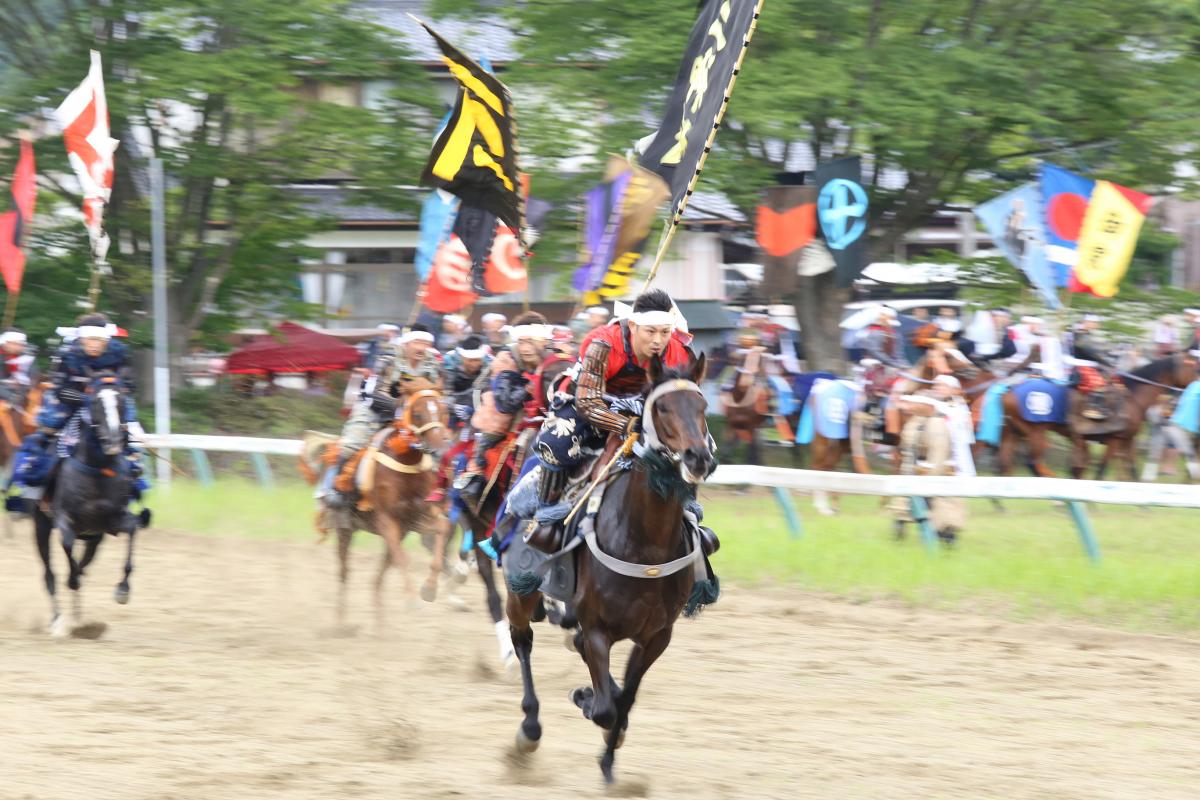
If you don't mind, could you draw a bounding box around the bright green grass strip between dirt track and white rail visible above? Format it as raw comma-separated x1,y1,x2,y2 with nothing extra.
151,480,1200,632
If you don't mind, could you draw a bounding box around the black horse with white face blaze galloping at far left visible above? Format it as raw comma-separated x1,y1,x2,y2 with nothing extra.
32,374,150,638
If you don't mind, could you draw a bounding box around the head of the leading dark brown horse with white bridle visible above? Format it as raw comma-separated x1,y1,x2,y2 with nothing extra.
642,355,716,485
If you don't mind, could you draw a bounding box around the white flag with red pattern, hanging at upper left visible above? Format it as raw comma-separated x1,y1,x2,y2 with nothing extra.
54,50,120,261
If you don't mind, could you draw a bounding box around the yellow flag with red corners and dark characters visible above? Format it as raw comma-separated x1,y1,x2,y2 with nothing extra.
1070,181,1151,297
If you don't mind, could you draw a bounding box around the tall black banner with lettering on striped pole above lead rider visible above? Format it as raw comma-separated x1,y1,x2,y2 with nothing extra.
640,0,764,287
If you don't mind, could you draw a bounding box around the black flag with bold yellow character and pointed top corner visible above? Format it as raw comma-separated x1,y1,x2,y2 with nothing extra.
414,17,524,236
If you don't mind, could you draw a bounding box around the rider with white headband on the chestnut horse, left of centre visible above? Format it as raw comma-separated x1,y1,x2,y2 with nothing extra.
317,323,442,507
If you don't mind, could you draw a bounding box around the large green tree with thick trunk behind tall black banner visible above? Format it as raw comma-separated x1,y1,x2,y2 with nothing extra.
439,0,1200,368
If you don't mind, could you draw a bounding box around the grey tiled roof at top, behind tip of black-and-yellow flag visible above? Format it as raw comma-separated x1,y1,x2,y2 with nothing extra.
354,0,517,62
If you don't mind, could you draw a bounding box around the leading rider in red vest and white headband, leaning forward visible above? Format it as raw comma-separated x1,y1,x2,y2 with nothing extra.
535,289,691,506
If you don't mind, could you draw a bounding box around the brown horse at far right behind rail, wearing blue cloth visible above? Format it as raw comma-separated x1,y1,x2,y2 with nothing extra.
1000,354,1196,481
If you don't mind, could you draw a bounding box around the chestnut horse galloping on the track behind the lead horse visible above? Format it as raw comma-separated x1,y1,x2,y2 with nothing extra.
325,389,450,622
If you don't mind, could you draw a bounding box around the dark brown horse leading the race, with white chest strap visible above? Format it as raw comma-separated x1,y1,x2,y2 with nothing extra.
506,356,715,783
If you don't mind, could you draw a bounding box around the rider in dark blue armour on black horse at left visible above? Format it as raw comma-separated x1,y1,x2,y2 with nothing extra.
10,313,149,499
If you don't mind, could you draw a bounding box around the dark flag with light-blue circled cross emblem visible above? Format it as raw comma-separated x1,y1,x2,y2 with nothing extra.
814,156,870,288
